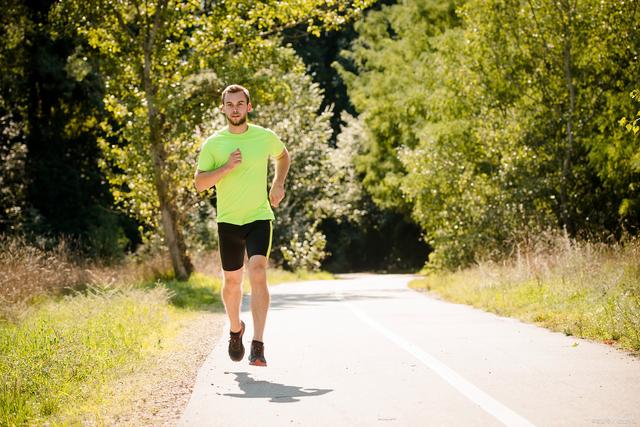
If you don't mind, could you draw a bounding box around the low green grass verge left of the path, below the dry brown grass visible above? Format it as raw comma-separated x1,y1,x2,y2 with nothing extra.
0,269,332,426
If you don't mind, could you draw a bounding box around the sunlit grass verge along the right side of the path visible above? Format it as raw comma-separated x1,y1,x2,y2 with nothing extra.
410,236,640,352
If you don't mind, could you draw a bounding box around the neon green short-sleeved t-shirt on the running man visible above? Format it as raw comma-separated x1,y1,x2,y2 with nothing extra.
198,124,284,225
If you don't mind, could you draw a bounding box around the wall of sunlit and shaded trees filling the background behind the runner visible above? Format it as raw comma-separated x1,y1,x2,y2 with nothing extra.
0,0,640,277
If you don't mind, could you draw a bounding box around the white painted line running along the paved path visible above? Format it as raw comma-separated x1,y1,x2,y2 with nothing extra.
336,300,534,427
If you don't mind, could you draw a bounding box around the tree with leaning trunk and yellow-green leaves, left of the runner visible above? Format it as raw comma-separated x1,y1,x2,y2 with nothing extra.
54,0,378,279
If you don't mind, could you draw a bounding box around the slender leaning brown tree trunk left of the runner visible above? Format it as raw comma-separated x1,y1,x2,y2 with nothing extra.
143,2,193,280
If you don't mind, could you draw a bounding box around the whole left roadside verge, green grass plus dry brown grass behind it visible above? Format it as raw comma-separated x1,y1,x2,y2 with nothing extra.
0,239,331,426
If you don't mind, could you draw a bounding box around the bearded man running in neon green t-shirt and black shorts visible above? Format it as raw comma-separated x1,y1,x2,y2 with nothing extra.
195,85,291,366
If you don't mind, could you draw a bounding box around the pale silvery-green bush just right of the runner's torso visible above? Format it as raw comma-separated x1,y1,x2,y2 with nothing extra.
248,66,339,270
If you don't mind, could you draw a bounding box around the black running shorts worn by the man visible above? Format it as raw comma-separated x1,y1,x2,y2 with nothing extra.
218,220,273,271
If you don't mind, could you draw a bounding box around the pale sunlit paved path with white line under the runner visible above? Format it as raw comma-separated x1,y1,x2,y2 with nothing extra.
180,275,640,427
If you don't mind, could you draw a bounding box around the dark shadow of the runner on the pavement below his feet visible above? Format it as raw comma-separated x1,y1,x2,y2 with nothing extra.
224,372,333,403
